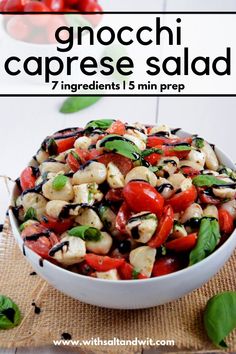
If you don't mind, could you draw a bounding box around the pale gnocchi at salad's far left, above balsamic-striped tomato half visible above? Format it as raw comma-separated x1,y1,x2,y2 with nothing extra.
22,192,47,219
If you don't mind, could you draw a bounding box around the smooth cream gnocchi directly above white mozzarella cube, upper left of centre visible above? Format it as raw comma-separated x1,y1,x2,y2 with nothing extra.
72,161,107,184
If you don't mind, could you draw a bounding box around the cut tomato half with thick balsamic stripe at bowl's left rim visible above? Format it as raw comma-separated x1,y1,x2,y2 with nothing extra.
21,223,59,259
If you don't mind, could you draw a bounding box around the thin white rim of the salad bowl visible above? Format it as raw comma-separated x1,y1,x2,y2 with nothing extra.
9,129,236,284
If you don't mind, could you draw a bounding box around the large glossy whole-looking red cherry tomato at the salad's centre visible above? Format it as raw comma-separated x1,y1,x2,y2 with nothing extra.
123,181,164,217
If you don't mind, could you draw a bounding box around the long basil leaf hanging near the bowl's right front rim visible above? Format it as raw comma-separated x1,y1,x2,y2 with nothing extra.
189,218,221,266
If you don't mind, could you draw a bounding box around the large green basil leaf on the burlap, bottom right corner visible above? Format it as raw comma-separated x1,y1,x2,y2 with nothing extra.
204,291,236,349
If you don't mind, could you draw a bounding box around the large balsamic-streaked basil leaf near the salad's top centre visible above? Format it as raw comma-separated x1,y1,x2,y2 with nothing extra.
100,134,141,160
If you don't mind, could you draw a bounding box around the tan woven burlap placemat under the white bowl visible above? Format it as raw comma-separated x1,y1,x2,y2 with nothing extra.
0,220,236,353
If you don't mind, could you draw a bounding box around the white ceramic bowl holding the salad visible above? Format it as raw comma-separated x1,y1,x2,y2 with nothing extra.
9,131,236,309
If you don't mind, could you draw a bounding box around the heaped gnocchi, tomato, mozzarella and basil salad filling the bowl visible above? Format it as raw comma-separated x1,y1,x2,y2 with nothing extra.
13,119,236,280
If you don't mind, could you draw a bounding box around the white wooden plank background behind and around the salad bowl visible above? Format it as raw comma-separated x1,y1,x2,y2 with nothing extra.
0,0,236,354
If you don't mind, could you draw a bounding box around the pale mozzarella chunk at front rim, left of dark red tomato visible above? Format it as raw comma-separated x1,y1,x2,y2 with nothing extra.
129,246,156,278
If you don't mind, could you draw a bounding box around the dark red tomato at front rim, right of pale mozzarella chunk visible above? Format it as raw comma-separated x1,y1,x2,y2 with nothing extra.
152,256,181,277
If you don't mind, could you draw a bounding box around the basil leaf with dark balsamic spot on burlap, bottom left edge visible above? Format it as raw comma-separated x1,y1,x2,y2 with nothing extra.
0,295,21,329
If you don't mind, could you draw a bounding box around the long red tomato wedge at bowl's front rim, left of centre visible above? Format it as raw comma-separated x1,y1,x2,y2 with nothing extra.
85,253,124,272
